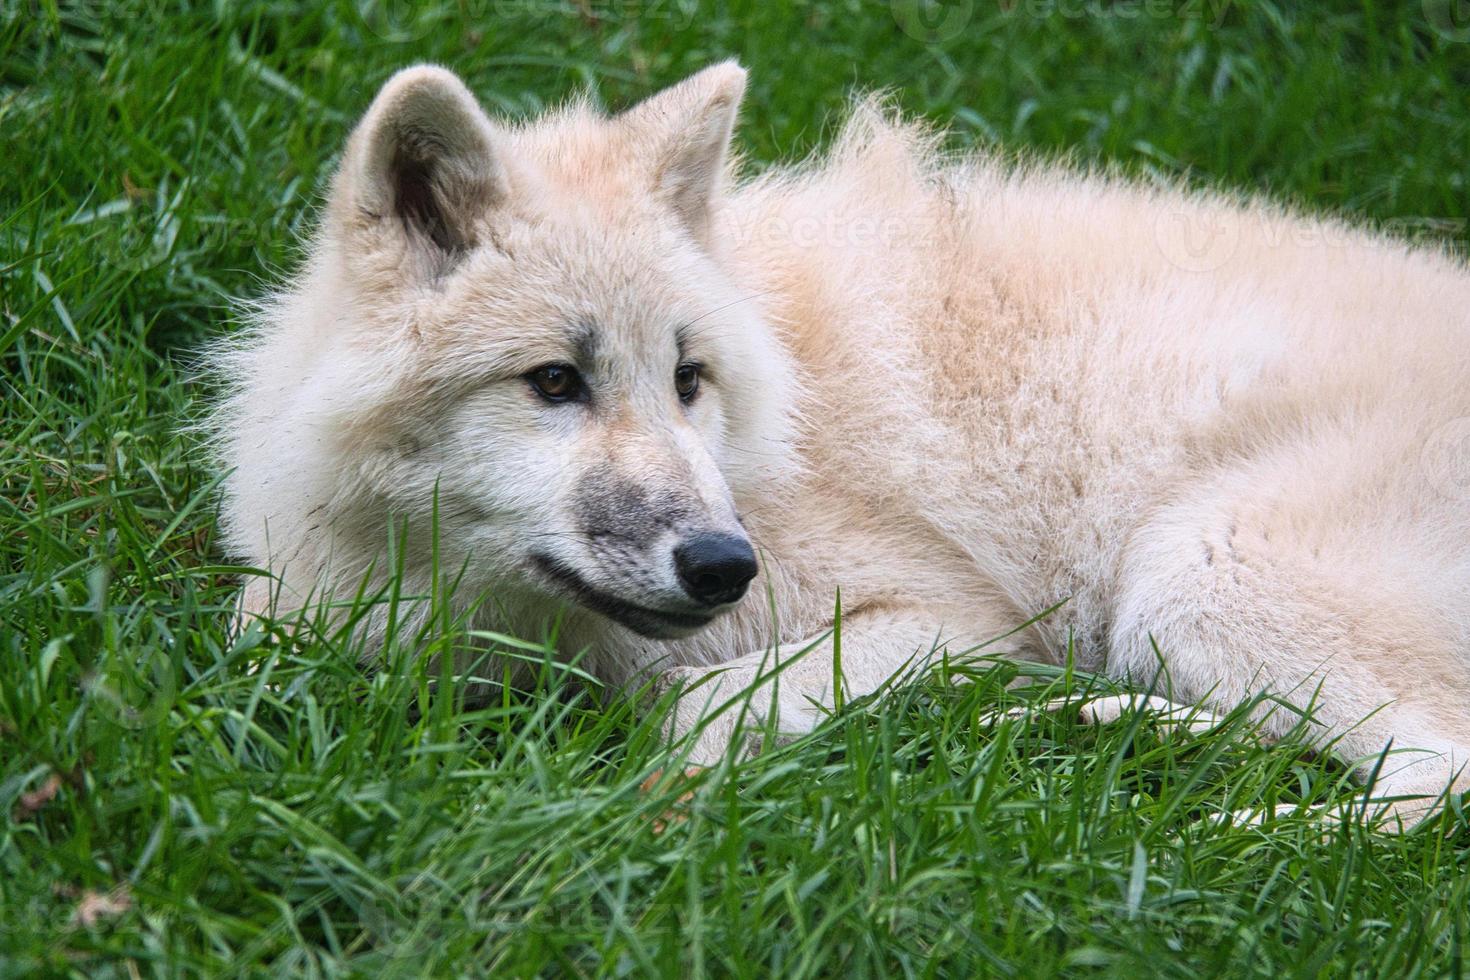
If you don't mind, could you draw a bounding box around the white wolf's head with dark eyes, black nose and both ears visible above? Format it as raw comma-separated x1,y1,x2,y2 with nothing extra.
221,63,792,638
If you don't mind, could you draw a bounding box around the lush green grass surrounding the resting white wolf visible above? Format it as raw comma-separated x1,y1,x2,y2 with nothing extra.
0,0,1470,977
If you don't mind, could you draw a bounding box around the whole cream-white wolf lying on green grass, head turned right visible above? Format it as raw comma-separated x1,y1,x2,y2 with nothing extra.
216,63,1470,818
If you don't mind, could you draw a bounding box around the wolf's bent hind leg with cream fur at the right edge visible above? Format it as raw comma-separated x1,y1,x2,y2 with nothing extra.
1108,478,1470,829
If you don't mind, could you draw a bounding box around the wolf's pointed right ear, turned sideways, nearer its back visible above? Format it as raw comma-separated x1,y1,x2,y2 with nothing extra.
622,60,745,242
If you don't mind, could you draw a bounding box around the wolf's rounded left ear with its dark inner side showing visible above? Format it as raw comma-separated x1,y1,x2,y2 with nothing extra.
332,65,509,275
